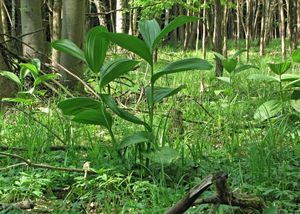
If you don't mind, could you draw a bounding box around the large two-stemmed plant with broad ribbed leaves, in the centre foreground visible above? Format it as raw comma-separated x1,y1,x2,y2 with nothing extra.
53,16,212,164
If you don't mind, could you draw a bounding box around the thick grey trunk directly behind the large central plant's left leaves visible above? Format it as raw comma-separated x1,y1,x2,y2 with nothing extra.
60,0,86,89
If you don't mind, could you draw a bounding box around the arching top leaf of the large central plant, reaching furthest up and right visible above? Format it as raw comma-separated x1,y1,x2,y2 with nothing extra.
152,16,198,50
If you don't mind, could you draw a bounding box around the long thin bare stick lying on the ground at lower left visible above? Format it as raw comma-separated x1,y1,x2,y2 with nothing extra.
0,152,97,174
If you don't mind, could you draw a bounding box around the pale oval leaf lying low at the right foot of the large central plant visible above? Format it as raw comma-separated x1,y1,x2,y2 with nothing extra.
148,147,180,164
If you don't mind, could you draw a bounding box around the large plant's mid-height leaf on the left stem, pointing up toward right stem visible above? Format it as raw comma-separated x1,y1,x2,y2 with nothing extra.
100,59,139,87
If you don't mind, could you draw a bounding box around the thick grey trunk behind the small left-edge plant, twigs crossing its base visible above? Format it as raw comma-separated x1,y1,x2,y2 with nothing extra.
20,0,46,58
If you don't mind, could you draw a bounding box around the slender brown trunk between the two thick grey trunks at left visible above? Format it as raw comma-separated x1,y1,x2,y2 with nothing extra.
51,0,62,64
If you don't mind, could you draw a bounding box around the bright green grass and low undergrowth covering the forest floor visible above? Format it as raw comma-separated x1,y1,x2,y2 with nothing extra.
0,41,300,213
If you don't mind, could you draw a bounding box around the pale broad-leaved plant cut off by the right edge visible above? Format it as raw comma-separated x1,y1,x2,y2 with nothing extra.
248,49,300,121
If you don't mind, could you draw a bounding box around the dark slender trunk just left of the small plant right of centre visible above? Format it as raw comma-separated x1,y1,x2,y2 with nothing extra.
213,0,223,77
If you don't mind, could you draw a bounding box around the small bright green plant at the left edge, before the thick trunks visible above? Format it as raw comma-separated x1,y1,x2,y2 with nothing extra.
0,59,59,104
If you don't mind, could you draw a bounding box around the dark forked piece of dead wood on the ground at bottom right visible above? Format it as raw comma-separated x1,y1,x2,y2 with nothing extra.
166,172,265,214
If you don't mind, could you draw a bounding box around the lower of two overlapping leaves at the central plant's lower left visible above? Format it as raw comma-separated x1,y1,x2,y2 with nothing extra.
72,109,113,129
